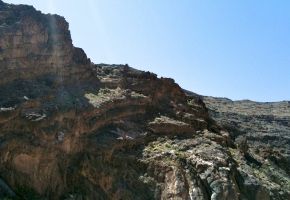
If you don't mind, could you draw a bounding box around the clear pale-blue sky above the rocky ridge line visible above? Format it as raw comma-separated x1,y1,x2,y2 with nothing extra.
4,0,290,101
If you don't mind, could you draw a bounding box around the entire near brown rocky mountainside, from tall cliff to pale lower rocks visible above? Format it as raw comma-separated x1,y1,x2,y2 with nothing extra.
0,1,290,200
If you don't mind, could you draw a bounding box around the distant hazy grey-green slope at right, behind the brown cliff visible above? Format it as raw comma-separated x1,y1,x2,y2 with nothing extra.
203,97,290,199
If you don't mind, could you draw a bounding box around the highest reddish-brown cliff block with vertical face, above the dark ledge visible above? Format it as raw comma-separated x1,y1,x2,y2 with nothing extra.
0,0,90,84
